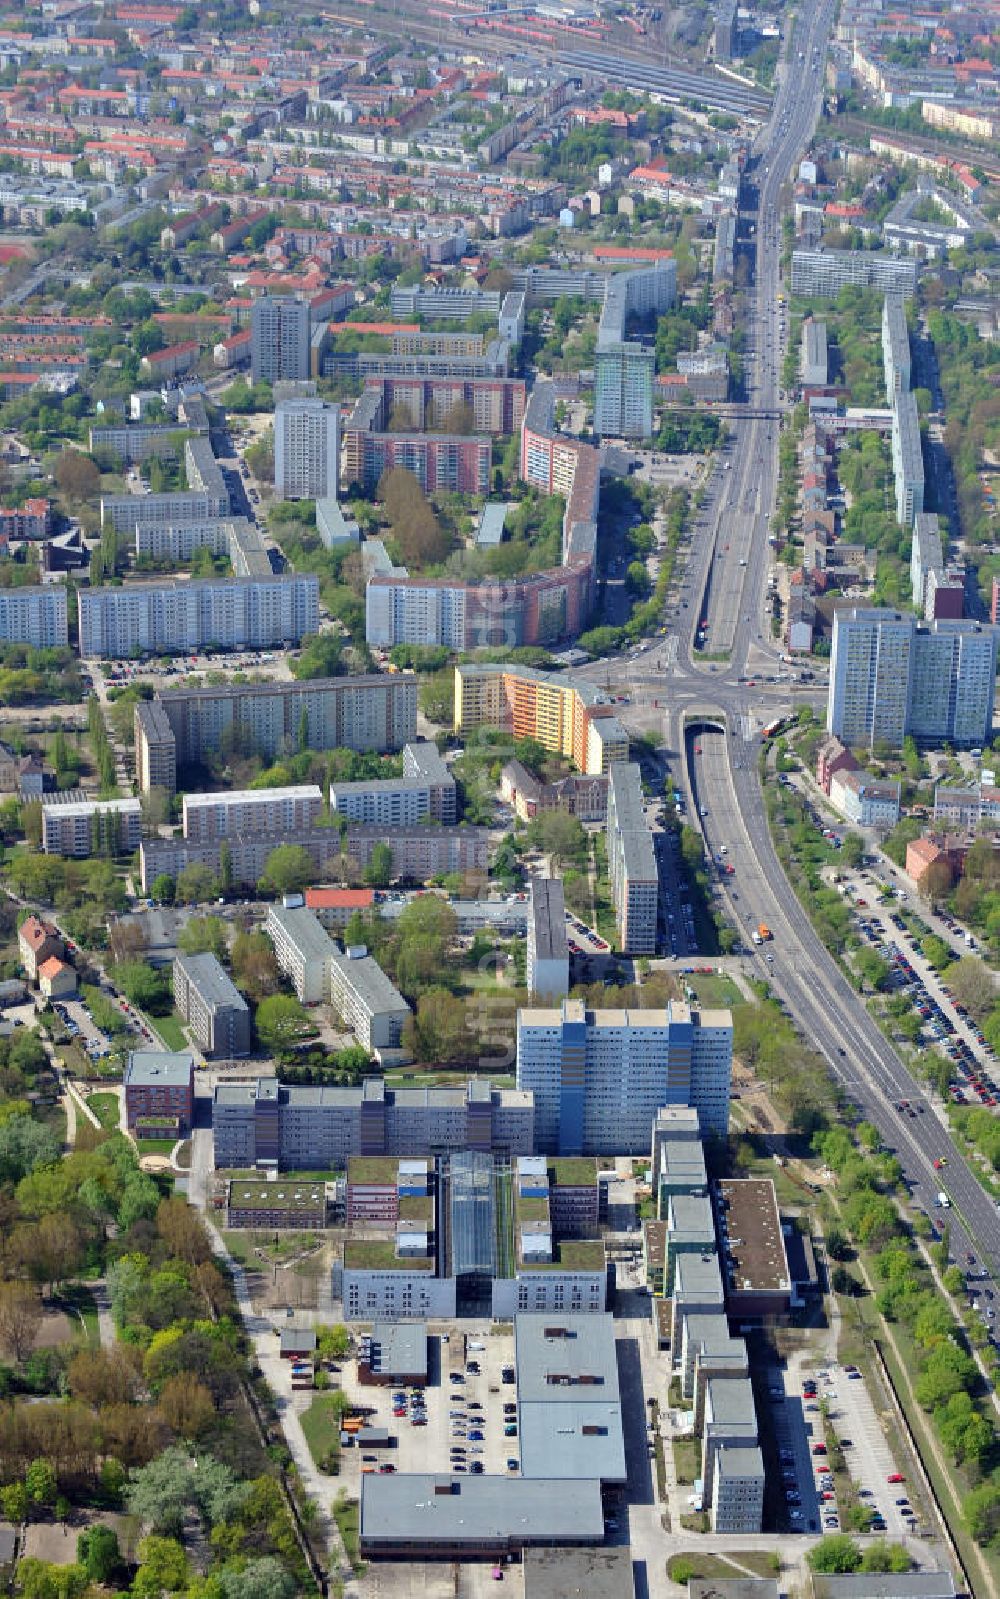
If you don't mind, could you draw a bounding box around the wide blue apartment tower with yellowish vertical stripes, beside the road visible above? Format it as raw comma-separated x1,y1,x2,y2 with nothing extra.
517,999,733,1154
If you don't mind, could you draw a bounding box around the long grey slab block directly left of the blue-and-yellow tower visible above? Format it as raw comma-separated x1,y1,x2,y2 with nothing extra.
213,1078,534,1170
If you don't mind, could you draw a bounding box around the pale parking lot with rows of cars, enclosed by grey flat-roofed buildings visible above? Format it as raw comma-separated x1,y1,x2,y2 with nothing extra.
341,1330,520,1484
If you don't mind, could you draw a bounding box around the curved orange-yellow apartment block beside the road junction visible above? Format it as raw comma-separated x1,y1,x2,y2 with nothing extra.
454,662,629,774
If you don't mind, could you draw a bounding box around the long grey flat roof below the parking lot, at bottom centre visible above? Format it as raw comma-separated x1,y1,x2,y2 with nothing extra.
360,1471,605,1554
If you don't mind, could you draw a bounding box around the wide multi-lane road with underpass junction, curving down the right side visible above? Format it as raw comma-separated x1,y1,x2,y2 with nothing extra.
572,0,1000,1274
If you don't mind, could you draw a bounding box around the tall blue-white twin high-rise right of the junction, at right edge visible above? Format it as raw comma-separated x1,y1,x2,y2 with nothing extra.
827,608,997,748
